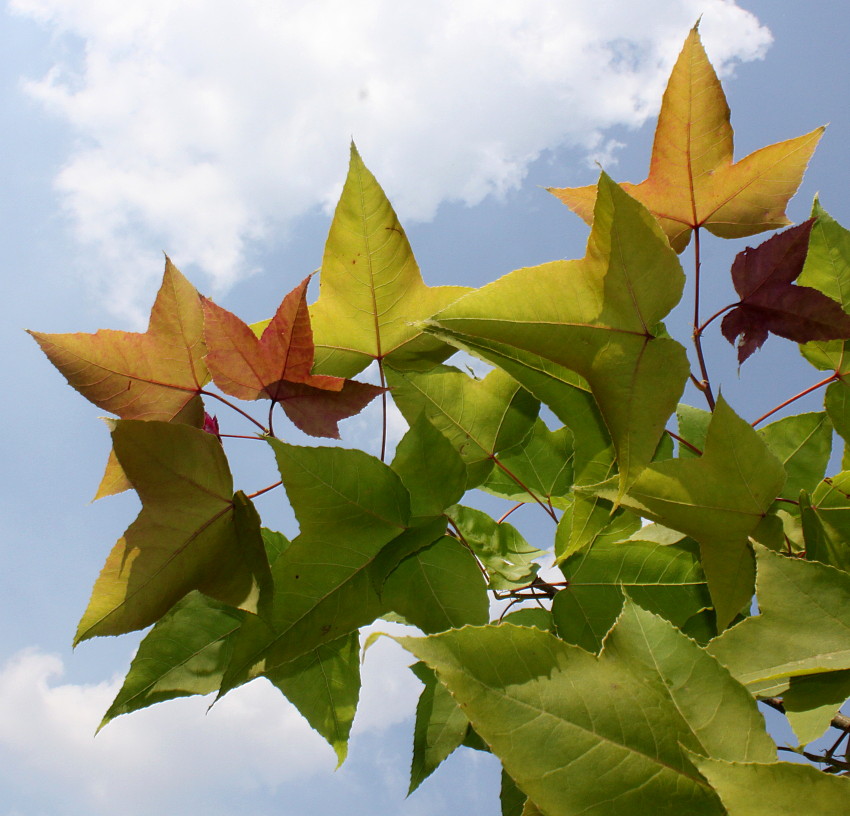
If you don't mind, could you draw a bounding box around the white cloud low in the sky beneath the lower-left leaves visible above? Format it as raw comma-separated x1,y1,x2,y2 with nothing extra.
0,624,420,816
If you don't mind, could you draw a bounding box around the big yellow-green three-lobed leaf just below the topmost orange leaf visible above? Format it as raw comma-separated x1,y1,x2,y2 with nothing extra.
433,173,688,498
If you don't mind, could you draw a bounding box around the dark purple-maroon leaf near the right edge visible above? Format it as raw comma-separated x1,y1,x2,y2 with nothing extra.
721,223,850,363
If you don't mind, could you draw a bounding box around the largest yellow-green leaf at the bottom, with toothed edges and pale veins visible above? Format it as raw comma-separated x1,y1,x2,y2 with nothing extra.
397,603,775,816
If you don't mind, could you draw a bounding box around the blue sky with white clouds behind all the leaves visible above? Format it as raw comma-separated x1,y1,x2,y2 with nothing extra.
0,0,850,816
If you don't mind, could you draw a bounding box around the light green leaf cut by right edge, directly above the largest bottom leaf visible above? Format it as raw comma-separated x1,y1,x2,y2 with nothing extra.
708,547,850,689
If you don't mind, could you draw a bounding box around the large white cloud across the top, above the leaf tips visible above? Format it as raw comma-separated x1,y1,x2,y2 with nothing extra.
10,0,770,317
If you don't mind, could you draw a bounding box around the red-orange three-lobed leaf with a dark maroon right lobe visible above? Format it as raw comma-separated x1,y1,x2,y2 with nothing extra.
203,278,384,439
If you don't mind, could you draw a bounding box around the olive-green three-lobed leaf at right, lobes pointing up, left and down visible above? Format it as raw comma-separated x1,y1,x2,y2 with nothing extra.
602,397,785,629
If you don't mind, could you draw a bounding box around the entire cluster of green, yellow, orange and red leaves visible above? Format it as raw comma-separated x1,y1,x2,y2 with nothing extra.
32,22,850,816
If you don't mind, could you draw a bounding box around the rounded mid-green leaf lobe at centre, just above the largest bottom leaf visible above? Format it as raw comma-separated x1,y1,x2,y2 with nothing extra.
381,536,490,634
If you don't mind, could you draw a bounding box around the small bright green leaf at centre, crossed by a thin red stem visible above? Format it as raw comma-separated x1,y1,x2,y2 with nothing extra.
479,418,575,509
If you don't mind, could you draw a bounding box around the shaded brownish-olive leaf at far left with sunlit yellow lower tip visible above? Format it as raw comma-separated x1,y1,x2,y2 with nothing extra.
74,420,271,643
